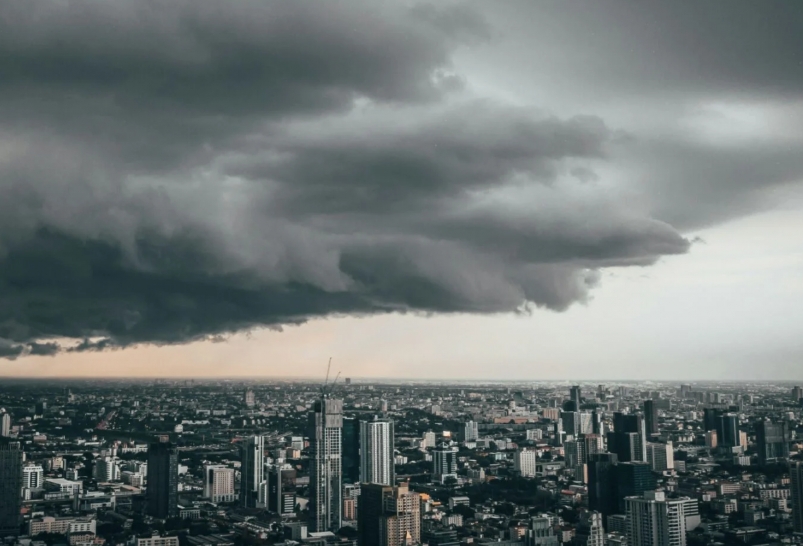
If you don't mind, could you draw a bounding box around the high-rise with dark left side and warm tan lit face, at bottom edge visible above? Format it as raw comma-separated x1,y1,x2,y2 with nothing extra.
357,484,421,546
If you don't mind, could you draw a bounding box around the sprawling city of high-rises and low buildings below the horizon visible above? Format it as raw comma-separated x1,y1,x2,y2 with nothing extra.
0,377,803,546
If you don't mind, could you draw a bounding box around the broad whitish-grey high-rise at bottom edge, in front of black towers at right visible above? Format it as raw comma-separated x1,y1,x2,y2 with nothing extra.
625,491,688,546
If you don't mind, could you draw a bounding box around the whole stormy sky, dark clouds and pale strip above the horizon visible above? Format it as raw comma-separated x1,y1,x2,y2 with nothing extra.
0,0,803,381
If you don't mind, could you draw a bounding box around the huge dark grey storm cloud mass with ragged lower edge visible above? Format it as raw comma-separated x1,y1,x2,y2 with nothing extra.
0,0,688,357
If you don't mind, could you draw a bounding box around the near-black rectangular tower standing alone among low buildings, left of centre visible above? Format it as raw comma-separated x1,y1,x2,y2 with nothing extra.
145,441,178,519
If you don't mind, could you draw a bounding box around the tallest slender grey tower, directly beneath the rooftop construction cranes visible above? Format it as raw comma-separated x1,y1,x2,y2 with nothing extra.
308,395,343,532
